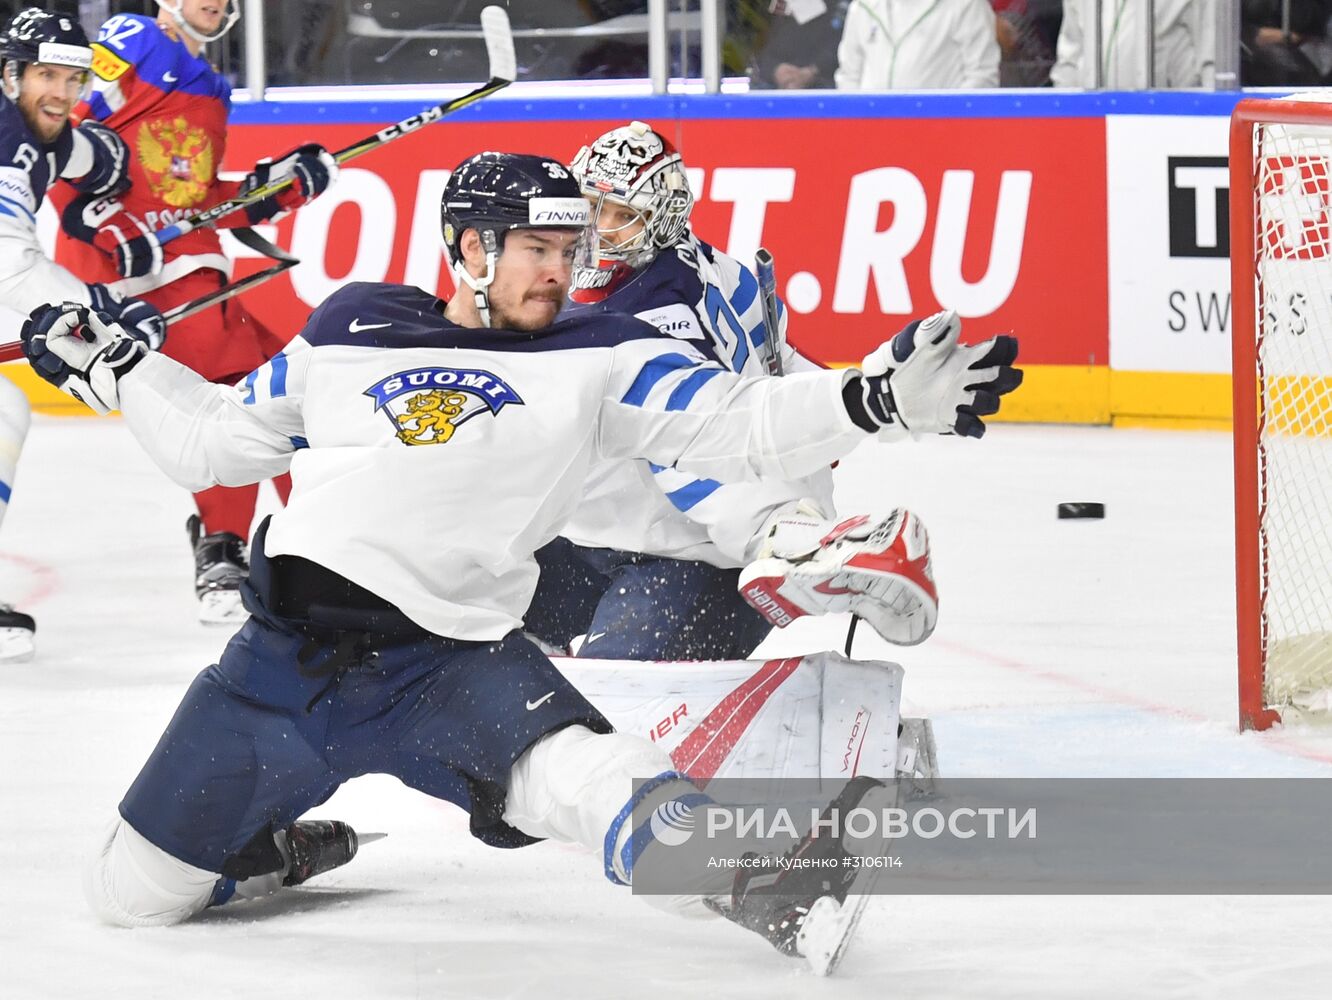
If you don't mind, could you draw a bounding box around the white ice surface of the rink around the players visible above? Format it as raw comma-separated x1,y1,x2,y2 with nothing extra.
0,418,1332,1000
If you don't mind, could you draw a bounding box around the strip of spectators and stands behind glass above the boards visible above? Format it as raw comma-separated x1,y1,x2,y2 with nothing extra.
0,0,1332,91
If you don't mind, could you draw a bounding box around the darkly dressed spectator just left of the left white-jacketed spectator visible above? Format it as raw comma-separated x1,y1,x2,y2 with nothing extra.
753,0,851,91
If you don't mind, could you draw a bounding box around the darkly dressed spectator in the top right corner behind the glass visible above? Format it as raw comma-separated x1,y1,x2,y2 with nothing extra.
1240,0,1332,87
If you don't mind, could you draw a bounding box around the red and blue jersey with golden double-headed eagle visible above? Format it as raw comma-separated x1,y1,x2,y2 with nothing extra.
76,15,232,256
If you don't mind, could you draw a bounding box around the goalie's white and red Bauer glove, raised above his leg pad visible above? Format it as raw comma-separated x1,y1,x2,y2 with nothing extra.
739,507,939,646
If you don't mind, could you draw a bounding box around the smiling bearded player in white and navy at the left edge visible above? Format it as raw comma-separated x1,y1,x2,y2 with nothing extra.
0,8,167,662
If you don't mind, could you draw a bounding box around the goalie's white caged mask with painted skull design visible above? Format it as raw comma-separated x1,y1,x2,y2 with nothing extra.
573,121,694,301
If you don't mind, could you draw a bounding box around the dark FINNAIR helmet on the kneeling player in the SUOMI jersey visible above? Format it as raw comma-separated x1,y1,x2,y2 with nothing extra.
440,153,589,265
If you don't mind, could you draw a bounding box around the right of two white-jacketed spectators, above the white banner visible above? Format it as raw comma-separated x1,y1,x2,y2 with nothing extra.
1050,0,1216,89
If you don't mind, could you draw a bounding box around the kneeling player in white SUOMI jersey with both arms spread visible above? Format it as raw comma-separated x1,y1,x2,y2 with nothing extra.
24,153,1011,960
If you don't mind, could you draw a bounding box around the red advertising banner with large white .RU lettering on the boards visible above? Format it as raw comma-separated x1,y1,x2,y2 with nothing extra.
226,117,1110,365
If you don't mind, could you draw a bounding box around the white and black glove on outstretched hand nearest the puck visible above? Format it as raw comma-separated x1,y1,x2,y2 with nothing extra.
842,309,1022,441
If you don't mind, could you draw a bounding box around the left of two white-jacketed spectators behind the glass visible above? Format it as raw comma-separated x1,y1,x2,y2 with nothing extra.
835,0,999,91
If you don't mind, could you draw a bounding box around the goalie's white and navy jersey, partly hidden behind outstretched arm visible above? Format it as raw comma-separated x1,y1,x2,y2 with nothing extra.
562,233,833,567
